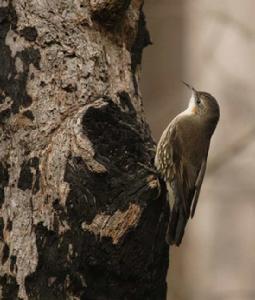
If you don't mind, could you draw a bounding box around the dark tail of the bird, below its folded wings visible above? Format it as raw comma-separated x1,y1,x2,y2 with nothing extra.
166,206,188,246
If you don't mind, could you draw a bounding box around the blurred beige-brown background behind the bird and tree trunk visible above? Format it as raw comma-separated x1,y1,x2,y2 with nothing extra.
142,0,255,300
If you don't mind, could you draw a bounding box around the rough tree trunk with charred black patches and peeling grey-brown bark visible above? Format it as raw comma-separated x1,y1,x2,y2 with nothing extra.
0,0,168,300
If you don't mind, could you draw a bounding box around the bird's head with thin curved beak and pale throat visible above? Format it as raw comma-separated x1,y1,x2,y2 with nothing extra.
183,82,220,132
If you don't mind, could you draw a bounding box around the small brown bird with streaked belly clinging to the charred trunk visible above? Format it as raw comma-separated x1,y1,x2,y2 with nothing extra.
154,82,220,246
